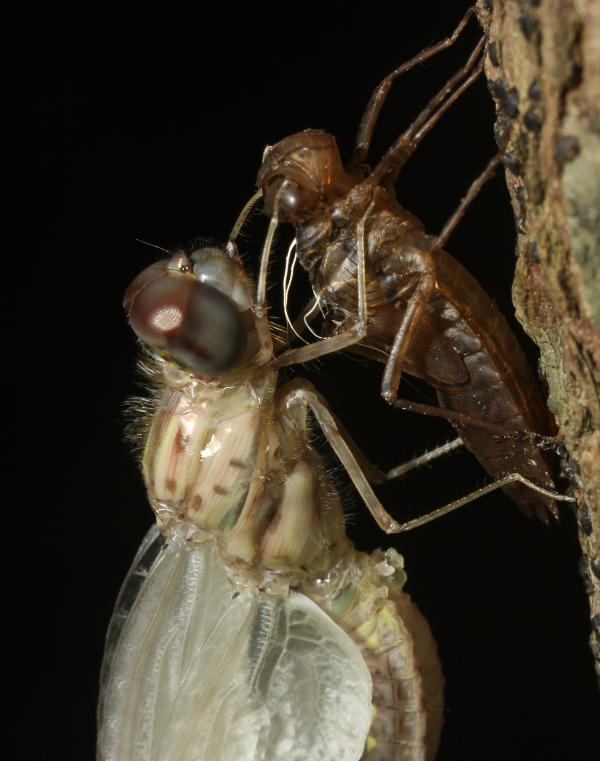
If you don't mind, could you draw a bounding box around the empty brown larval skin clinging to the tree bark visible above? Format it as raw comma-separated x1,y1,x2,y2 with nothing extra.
248,9,572,520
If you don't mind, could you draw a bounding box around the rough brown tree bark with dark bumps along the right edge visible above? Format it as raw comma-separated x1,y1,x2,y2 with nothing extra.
477,0,600,674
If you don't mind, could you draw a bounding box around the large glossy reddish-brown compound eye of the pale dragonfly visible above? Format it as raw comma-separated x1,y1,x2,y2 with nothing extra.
126,273,247,375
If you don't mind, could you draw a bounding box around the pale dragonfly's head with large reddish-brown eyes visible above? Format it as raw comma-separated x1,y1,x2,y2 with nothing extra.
123,244,268,377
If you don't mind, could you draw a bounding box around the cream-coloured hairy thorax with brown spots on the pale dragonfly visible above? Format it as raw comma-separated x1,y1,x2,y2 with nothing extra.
143,369,345,586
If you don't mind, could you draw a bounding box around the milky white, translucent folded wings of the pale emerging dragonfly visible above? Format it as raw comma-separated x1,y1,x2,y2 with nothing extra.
98,530,371,761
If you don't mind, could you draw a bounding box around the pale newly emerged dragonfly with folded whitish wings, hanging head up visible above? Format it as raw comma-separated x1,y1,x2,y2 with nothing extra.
97,235,443,761
